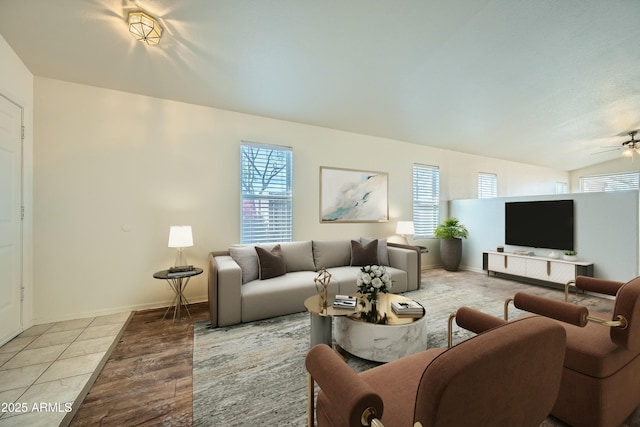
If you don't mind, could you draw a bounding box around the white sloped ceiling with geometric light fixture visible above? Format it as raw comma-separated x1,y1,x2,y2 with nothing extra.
0,0,640,170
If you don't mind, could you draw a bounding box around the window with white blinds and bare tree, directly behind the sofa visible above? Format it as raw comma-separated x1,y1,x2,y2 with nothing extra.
240,142,293,243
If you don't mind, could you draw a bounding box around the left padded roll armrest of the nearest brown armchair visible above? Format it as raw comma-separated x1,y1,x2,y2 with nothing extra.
305,344,383,426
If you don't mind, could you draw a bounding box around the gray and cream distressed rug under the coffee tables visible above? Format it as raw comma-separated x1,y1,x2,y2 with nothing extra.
193,281,638,427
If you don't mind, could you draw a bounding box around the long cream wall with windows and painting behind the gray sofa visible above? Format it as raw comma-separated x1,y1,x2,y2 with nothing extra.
34,77,568,323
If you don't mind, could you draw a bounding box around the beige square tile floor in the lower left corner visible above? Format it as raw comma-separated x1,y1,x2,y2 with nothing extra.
0,312,131,427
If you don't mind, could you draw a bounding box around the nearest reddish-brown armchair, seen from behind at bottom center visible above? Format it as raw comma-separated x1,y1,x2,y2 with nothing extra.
306,309,566,427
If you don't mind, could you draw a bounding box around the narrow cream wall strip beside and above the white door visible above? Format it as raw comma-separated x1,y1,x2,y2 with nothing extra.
0,36,33,329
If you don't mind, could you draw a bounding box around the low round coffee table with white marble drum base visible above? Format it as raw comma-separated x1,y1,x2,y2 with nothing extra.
334,294,428,362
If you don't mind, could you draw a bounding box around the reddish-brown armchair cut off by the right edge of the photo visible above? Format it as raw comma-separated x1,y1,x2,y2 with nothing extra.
505,276,640,427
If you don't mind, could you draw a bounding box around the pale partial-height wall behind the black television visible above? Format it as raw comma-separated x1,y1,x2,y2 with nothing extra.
451,191,639,282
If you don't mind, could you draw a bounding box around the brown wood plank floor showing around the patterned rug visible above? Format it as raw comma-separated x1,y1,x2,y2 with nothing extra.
70,269,613,427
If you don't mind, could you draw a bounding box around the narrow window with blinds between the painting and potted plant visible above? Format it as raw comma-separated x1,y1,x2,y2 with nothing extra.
413,164,440,238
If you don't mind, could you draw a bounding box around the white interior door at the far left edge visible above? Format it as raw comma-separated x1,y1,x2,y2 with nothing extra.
0,95,22,345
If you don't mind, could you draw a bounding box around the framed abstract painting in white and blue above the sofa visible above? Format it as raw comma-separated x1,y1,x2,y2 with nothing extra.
320,166,389,222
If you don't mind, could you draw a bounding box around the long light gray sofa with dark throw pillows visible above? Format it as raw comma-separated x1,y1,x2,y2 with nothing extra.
208,238,420,327
